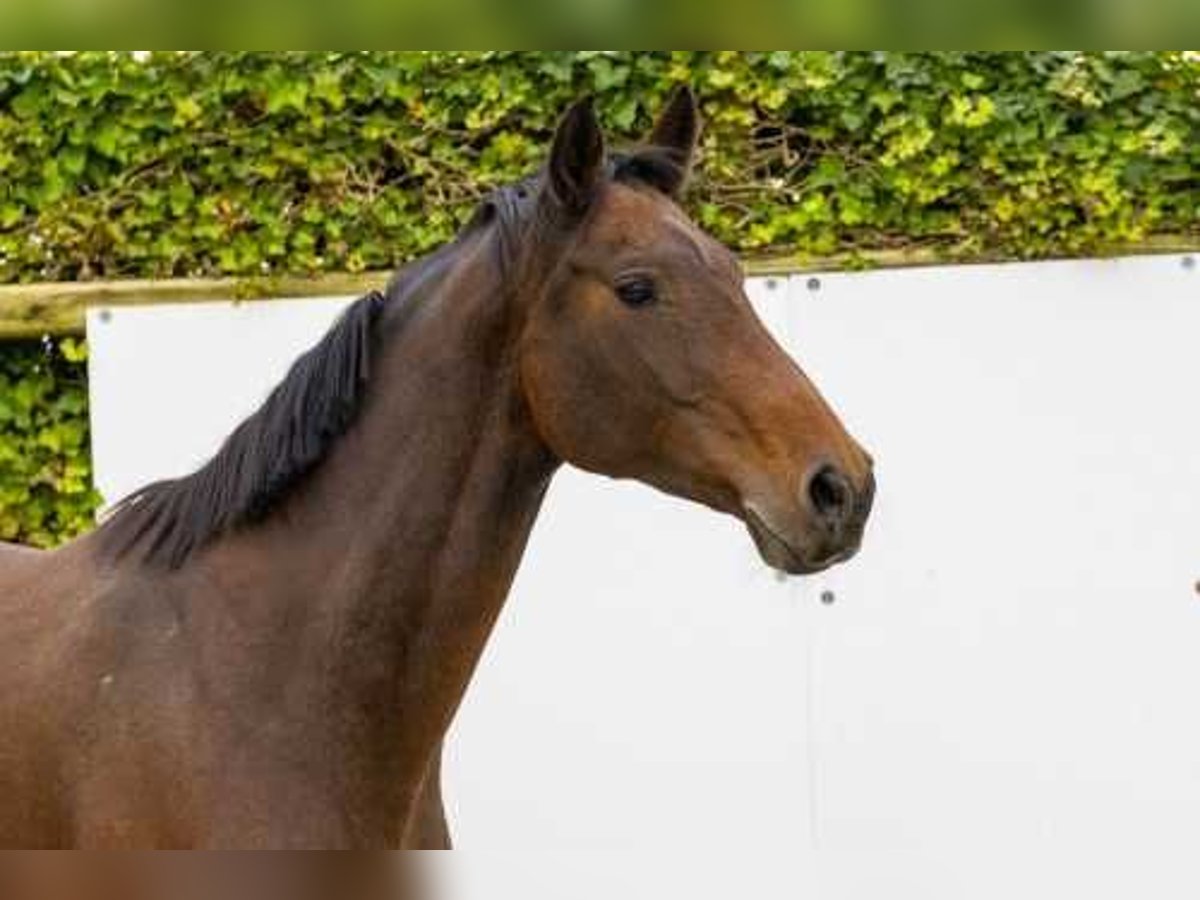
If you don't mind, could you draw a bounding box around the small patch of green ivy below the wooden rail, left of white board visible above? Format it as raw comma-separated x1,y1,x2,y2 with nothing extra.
0,340,96,546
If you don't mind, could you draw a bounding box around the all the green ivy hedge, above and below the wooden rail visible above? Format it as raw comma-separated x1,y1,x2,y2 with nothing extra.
0,50,1200,544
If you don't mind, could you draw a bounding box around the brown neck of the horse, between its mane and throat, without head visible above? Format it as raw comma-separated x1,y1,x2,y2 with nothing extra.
193,240,556,782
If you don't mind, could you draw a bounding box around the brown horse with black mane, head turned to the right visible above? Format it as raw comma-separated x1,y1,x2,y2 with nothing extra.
0,90,874,850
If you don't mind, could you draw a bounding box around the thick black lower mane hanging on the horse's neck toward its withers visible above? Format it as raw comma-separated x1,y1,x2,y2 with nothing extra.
102,293,384,568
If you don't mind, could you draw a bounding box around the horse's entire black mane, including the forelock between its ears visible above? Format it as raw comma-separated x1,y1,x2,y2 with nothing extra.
101,148,684,569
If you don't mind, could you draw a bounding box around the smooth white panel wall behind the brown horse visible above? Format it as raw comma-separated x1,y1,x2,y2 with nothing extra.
89,257,1200,900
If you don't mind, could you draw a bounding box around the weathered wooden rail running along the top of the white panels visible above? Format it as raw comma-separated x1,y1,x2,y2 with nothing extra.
0,235,1200,341
